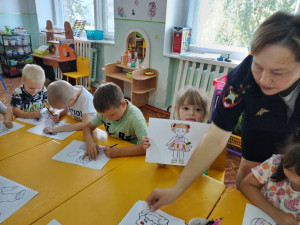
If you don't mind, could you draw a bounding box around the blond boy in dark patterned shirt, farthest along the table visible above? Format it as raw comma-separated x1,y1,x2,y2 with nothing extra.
10,64,47,119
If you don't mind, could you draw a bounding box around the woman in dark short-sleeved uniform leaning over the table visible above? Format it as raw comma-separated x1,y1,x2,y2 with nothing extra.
147,12,300,215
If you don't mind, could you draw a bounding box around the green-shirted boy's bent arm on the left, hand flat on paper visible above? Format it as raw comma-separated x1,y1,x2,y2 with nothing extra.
82,122,100,160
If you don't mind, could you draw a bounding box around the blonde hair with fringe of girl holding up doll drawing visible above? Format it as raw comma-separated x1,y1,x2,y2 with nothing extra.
175,86,208,119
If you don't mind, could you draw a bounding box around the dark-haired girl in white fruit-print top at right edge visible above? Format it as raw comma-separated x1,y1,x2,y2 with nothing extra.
241,139,300,225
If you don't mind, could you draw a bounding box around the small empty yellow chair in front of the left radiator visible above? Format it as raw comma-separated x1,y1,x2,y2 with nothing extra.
63,56,92,92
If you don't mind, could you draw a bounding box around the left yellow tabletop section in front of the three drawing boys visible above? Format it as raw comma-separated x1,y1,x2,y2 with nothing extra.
0,129,131,225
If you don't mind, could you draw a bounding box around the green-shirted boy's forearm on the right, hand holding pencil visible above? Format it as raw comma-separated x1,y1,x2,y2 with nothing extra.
104,143,146,158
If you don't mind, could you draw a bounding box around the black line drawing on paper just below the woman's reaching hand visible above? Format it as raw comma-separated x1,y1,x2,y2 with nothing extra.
136,209,169,225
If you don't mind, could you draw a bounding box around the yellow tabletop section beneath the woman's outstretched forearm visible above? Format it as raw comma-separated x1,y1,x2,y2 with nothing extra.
34,156,225,225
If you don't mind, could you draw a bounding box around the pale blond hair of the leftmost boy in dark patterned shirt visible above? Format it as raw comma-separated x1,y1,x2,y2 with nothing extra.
22,64,46,83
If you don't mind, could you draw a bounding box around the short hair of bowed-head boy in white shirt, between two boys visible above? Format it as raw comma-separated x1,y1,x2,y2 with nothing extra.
47,80,74,108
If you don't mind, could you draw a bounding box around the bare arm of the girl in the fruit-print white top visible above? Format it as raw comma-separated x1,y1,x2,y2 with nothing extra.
240,173,298,225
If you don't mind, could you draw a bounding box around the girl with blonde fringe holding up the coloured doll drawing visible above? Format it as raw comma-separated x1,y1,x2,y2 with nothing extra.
142,87,208,151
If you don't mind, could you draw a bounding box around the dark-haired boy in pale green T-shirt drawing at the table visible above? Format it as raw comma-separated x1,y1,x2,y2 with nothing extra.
83,83,147,160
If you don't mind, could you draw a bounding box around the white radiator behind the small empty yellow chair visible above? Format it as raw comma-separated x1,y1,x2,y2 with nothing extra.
39,33,98,88
